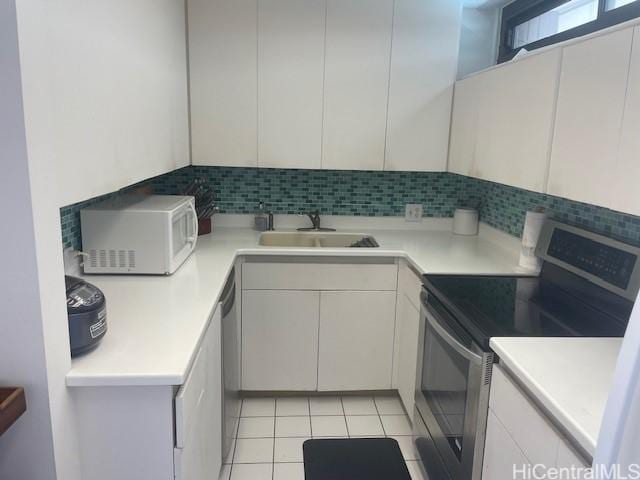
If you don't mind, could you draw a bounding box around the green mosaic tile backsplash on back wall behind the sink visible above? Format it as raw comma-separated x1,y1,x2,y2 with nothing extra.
151,167,479,217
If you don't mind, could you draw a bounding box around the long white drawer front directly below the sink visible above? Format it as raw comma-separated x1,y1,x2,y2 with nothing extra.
242,263,398,290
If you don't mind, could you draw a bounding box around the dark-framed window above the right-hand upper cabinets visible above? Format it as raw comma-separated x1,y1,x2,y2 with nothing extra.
498,0,640,62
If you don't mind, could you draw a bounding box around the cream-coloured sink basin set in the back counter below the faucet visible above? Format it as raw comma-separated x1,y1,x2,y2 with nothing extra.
258,232,379,248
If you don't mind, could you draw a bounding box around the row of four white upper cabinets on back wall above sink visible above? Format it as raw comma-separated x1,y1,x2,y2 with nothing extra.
188,0,461,171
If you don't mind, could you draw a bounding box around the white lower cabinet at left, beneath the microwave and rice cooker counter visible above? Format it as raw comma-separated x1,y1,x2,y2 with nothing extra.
70,308,222,480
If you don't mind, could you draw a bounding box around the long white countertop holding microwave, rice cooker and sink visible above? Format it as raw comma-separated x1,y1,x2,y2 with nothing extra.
66,222,519,386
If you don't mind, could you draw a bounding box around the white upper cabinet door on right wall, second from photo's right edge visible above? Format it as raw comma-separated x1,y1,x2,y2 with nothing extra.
548,29,633,206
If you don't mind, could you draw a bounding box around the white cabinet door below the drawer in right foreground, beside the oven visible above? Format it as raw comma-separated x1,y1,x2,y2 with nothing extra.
482,410,528,480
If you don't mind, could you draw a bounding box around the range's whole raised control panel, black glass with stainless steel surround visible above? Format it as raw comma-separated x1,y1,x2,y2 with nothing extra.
536,220,640,301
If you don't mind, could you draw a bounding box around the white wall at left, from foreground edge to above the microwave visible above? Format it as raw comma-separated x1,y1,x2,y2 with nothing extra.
0,0,189,480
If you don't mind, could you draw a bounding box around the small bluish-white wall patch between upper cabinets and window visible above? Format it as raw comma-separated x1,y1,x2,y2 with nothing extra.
458,6,501,79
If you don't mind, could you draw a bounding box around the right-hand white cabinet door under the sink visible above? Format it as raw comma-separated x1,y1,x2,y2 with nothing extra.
318,292,396,391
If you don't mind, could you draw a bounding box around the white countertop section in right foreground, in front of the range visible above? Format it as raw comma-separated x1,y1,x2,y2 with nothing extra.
491,338,622,456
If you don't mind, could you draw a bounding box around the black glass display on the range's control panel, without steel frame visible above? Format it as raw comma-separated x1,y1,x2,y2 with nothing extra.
547,229,638,289
